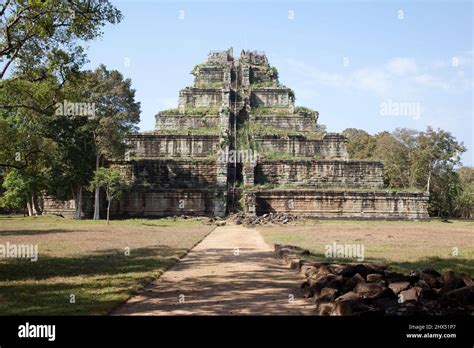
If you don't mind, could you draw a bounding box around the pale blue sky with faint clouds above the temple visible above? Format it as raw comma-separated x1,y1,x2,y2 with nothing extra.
83,0,474,166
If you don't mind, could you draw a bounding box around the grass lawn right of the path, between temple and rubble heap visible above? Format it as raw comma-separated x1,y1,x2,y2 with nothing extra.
259,220,474,277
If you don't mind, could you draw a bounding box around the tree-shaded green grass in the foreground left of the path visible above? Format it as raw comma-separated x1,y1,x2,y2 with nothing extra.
0,245,186,315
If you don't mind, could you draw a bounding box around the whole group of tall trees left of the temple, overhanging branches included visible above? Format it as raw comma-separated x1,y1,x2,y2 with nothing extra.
0,0,140,218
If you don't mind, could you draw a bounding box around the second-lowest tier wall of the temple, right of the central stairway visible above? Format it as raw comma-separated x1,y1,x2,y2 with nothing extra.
255,160,383,188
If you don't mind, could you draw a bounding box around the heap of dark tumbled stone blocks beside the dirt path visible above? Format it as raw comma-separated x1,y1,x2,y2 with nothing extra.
275,244,474,316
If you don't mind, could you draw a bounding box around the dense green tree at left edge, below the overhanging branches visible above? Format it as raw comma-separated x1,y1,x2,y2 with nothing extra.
0,76,57,215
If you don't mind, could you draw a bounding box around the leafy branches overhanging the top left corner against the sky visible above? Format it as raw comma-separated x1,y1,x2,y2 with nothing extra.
0,0,122,79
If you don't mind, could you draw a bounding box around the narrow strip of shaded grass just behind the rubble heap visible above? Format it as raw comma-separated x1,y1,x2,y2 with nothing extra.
305,253,474,277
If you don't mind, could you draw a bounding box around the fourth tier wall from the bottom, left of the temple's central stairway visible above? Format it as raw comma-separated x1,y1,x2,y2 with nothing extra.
155,114,219,130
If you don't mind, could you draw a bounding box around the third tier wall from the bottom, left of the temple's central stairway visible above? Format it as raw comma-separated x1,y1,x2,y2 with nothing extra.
127,134,219,159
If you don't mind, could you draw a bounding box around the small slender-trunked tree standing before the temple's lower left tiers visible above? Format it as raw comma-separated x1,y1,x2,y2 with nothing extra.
89,168,127,225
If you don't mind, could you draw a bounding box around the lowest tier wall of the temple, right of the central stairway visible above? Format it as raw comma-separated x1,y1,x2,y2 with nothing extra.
254,190,429,219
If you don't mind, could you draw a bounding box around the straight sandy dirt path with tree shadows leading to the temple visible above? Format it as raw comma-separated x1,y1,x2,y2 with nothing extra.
113,225,314,315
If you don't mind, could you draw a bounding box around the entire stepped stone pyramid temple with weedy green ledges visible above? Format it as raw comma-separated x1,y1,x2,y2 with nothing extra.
43,49,428,219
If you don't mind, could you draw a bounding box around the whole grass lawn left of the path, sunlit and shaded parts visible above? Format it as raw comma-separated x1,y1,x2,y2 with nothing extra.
0,216,213,315
